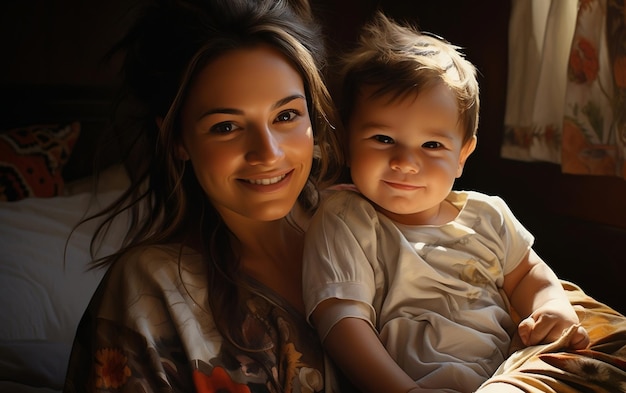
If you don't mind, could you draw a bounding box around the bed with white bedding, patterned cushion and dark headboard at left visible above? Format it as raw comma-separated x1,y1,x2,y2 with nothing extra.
0,88,128,393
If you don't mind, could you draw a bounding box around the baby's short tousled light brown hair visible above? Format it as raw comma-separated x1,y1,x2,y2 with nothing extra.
339,12,480,142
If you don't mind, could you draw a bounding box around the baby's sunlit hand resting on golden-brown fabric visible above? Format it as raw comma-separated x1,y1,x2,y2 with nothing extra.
517,304,589,349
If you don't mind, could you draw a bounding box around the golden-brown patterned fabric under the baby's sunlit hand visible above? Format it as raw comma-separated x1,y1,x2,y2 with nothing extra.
479,281,626,393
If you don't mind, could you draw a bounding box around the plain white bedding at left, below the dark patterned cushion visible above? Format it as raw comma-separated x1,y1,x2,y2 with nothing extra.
0,190,127,387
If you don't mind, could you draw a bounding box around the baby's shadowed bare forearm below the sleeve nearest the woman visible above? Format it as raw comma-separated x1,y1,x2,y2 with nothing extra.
312,299,419,393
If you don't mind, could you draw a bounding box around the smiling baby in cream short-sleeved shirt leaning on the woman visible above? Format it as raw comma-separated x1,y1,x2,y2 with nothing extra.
303,14,589,393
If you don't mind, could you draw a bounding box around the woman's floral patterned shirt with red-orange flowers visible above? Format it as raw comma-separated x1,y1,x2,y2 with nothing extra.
64,245,332,393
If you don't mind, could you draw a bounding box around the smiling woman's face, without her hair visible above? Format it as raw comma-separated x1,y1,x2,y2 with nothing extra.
179,45,313,221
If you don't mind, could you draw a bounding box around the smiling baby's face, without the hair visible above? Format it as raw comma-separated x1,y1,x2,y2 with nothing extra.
348,84,475,225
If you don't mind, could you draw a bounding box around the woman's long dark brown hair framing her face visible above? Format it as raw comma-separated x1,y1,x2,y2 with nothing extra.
77,0,343,380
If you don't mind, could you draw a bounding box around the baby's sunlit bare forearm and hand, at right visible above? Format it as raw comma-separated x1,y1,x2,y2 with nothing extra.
503,249,589,349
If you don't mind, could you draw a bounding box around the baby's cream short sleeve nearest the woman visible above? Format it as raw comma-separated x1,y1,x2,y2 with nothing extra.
303,191,379,339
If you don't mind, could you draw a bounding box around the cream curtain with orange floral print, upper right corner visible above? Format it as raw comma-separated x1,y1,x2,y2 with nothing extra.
501,0,626,178
